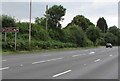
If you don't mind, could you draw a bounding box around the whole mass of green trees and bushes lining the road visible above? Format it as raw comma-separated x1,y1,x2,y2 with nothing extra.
0,5,120,54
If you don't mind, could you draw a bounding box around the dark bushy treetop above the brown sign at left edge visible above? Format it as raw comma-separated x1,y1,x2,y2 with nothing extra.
0,15,16,28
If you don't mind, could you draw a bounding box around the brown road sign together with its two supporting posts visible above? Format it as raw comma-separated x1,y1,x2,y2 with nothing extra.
0,27,19,51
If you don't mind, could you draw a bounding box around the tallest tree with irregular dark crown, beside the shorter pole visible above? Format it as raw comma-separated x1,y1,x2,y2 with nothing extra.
47,5,66,29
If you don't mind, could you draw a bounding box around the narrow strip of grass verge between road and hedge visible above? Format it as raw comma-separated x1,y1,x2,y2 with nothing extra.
2,46,100,55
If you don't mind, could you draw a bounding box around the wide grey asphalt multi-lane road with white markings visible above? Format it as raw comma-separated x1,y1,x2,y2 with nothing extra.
0,47,118,79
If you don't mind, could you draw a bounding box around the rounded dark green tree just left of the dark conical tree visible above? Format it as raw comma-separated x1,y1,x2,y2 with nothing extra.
86,26,100,45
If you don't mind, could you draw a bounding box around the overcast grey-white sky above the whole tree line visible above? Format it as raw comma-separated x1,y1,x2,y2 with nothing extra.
0,0,118,27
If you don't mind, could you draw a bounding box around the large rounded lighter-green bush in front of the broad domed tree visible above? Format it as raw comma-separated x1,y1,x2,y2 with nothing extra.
63,25,86,47
